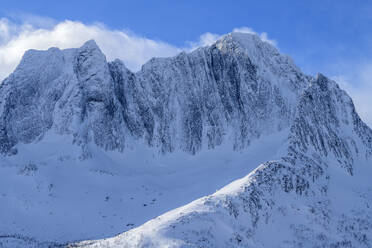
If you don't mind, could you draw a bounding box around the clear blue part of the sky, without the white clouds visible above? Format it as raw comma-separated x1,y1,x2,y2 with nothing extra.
0,0,372,123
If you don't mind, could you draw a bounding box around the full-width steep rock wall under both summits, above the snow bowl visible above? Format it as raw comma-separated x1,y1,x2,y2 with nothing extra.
0,33,310,157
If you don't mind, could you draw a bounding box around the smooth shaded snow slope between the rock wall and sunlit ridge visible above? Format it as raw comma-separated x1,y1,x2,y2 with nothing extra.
0,128,285,246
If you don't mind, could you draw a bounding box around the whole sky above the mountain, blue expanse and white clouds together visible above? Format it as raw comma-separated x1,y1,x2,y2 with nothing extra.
0,0,372,125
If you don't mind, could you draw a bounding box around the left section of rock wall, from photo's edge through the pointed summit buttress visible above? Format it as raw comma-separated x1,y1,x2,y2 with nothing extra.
0,41,132,155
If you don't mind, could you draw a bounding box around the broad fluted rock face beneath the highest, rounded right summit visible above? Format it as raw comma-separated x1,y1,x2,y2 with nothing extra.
136,34,309,153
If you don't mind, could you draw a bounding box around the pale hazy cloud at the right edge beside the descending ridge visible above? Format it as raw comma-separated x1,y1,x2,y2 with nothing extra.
332,62,372,127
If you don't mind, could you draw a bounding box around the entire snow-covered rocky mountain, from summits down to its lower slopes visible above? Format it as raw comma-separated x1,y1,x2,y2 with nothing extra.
0,33,372,247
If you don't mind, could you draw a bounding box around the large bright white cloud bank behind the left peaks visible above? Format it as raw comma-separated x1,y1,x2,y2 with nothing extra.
0,17,181,79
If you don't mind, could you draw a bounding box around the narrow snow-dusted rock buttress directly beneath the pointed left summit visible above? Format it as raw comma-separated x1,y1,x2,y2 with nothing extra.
66,41,127,155
